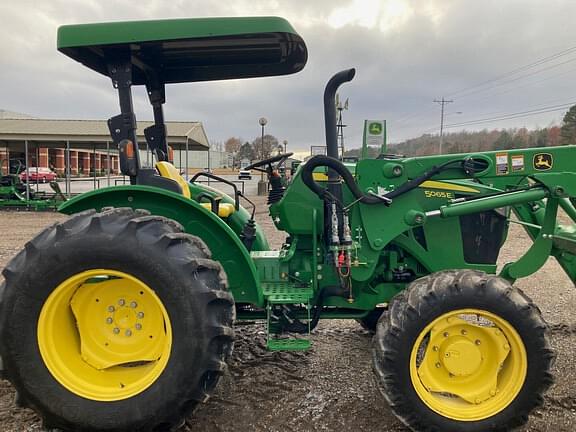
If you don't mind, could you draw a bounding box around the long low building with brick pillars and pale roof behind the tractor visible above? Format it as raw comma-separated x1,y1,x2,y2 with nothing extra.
0,115,209,176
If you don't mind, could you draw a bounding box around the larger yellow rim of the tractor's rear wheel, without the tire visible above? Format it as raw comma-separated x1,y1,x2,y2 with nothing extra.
38,269,172,401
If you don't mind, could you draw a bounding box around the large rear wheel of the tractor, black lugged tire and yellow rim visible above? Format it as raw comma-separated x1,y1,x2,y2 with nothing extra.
0,209,235,431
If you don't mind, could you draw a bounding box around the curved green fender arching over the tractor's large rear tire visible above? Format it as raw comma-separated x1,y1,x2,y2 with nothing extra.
58,186,264,307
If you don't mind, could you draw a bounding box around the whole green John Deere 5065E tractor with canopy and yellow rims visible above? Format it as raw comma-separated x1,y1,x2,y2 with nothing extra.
0,17,576,431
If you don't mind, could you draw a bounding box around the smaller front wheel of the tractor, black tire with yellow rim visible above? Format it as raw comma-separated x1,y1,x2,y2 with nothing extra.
373,270,554,432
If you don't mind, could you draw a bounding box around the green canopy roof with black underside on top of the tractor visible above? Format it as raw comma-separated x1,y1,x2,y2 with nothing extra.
58,17,307,84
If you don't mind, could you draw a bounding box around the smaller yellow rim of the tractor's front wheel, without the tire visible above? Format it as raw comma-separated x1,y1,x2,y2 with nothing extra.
410,309,528,421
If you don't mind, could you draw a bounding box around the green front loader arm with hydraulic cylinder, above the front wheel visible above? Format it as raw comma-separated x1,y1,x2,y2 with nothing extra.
354,146,576,282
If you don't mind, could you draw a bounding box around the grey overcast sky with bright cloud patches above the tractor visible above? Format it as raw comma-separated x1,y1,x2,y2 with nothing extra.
0,0,576,155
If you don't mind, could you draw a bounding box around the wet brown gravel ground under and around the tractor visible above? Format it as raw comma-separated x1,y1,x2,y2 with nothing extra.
0,199,576,432
